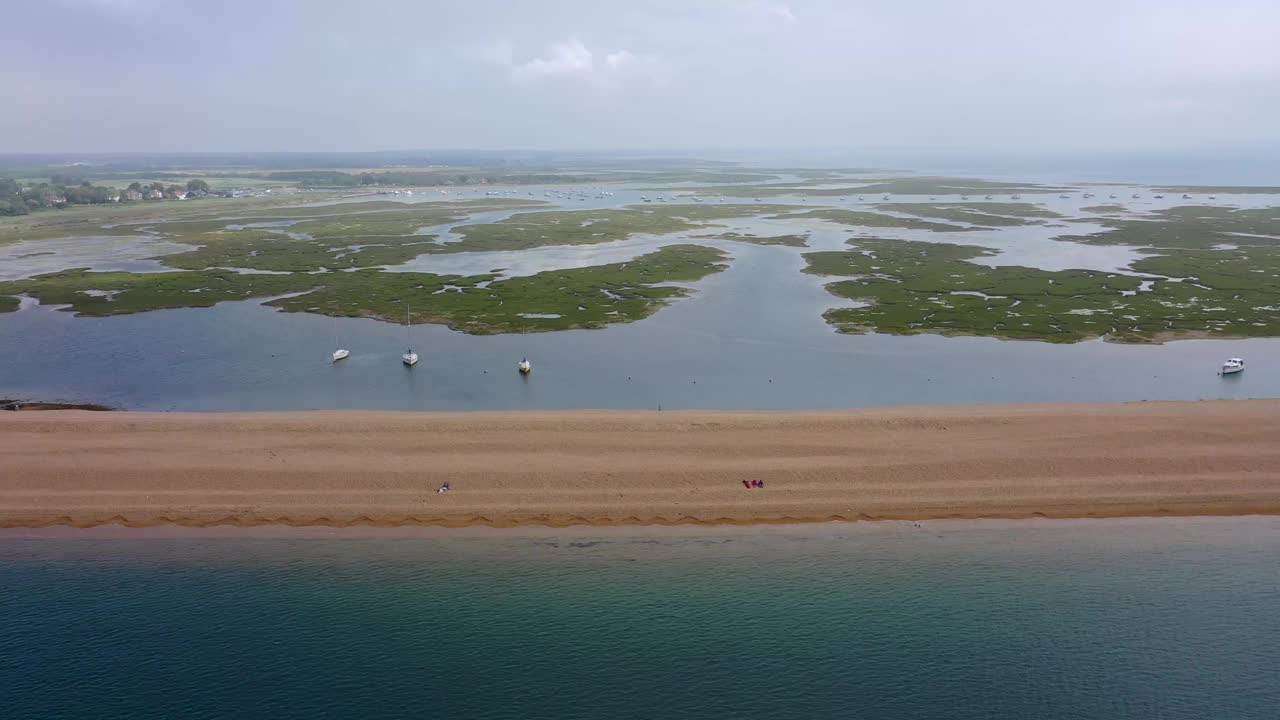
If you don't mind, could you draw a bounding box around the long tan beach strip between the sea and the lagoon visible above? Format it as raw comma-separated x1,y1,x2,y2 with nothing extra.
0,400,1280,527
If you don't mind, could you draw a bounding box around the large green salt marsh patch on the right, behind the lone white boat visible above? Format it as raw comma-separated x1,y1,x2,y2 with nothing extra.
805,238,1280,342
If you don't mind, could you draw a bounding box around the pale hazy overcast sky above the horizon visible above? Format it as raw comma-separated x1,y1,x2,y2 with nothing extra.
0,0,1280,152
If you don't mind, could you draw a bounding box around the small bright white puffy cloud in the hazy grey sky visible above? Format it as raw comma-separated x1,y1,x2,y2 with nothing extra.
508,38,667,88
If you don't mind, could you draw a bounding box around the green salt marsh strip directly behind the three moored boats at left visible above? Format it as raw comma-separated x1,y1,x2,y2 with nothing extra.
0,245,726,334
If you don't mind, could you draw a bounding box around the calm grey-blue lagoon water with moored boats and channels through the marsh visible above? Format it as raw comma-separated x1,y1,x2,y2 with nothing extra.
0,186,1280,410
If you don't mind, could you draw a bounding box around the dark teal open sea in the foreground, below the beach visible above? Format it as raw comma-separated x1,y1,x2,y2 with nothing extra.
0,519,1280,719
